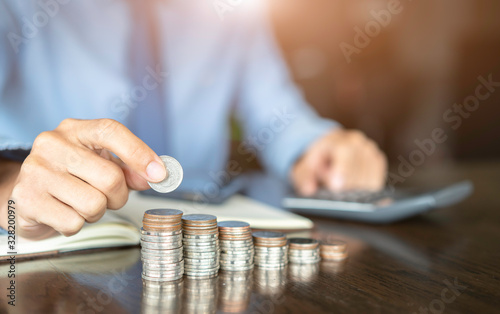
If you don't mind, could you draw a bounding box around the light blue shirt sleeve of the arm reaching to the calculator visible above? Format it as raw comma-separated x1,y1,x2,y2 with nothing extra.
236,1,340,180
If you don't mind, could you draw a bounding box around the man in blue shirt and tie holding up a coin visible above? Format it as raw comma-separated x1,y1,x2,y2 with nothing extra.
0,0,387,239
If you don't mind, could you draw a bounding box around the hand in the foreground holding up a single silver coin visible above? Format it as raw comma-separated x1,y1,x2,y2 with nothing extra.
3,119,167,239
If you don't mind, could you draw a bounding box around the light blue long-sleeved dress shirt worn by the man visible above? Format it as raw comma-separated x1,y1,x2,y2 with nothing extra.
0,0,337,184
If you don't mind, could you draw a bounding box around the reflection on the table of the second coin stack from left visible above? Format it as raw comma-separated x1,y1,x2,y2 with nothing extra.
182,277,218,313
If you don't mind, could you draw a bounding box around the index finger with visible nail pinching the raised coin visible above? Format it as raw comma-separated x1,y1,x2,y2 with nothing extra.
63,119,167,182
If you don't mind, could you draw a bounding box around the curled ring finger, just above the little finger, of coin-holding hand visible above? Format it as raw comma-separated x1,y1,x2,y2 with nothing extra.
48,173,108,222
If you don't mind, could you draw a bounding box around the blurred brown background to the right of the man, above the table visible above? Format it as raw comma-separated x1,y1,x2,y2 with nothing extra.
264,0,500,165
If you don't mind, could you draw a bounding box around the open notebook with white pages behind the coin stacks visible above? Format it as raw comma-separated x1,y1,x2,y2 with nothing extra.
0,192,313,260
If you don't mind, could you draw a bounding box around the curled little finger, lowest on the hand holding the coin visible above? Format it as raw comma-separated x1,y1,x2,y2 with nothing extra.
30,194,85,236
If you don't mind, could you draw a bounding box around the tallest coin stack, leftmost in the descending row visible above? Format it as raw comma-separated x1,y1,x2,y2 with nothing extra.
141,209,184,281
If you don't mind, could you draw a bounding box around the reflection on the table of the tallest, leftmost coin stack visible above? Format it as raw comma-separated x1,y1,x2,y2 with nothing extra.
141,279,183,314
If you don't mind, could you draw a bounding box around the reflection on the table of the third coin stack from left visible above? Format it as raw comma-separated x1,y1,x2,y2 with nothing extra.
219,269,253,313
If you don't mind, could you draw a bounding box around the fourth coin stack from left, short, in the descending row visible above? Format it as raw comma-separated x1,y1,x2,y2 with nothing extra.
253,231,288,268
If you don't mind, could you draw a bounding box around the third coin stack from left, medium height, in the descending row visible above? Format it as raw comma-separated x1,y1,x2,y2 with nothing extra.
218,221,254,271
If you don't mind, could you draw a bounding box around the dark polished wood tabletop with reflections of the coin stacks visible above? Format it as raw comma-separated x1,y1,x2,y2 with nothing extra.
0,163,500,313
